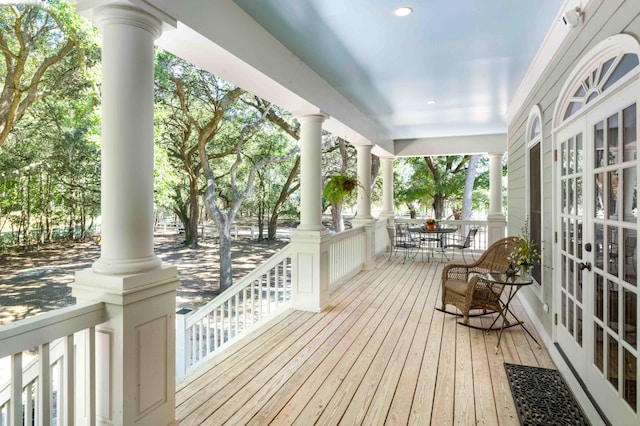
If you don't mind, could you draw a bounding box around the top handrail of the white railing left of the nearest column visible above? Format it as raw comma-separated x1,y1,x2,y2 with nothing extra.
0,302,106,358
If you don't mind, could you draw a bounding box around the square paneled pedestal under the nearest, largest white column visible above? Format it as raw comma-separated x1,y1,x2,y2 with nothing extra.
71,266,179,425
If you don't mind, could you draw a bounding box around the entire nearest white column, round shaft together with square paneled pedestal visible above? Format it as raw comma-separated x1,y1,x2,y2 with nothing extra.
71,3,179,425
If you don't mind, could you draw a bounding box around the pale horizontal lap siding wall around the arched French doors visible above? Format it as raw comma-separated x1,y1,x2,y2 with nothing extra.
508,0,640,335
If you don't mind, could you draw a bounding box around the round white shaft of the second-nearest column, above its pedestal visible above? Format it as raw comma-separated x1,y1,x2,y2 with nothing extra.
298,114,325,231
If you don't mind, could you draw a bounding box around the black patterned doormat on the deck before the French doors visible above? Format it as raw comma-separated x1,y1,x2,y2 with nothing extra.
504,362,589,426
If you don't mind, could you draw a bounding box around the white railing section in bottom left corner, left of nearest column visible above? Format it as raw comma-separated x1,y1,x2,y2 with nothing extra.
0,302,106,426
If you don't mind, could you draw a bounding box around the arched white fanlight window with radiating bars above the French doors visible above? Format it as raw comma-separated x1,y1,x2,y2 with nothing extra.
554,34,640,126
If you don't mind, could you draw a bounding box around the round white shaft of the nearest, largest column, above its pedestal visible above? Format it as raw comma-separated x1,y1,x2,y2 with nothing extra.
93,7,161,274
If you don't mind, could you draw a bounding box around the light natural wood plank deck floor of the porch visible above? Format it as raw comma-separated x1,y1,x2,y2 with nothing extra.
176,257,554,425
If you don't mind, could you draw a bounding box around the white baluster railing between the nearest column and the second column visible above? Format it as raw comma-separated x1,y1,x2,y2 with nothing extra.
176,244,292,378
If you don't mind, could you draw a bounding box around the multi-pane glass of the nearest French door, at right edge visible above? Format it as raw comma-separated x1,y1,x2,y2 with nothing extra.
583,104,638,413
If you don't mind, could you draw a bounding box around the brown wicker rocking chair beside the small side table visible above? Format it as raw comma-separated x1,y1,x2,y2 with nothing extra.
439,237,518,325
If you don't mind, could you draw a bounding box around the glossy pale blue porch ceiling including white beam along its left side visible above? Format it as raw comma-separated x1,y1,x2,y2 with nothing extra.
146,0,571,155
